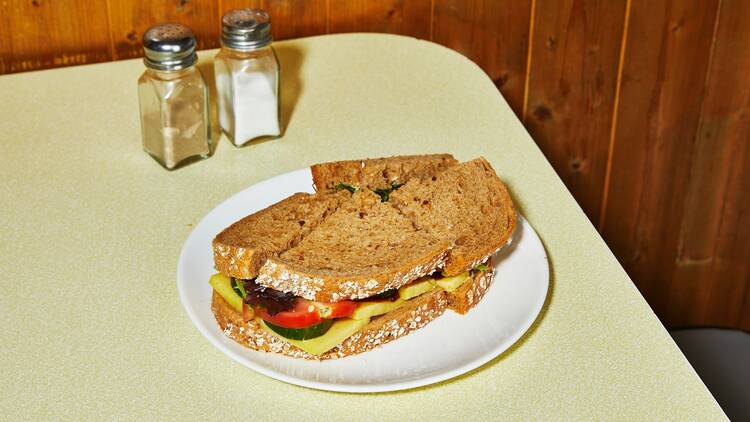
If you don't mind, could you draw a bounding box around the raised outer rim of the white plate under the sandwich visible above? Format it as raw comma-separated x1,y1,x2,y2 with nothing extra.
176,167,550,393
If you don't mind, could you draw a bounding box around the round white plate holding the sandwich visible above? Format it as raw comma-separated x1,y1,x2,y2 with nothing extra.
177,169,549,392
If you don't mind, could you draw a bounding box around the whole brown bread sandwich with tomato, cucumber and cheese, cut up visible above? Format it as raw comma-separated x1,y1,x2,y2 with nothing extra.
210,154,516,360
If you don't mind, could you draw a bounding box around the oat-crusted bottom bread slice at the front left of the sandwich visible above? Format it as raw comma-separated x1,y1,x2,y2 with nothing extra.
211,289,448,360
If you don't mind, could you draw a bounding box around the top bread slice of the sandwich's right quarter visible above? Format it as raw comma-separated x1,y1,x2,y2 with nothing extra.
390,158,516,276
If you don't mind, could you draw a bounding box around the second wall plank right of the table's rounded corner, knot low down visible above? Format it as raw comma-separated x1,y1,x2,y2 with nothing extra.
524,0,627,221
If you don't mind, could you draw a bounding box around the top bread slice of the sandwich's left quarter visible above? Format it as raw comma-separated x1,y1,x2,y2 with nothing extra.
213,191,351,279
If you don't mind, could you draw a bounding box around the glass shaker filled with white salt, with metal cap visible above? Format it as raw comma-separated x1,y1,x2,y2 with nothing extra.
214,9,281,146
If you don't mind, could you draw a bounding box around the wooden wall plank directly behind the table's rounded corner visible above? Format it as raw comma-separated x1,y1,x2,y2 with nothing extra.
432,0,532,117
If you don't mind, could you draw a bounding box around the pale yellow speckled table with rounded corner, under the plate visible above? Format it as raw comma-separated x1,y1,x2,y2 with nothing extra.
0,34,725,421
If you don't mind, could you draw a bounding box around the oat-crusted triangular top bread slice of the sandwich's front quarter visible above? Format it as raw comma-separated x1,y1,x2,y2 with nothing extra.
256,190,450,302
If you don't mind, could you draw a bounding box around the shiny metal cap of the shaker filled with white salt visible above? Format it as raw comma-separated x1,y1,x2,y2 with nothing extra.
221,9,273,50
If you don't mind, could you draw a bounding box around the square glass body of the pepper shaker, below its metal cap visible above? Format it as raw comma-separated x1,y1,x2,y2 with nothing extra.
138,66,211,170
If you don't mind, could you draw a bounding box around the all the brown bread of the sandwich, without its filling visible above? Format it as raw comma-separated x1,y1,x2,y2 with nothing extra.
211,154,516,359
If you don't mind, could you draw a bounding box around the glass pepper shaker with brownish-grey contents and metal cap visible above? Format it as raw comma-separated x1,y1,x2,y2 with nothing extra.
138,23,211,170
